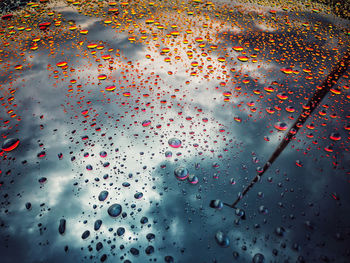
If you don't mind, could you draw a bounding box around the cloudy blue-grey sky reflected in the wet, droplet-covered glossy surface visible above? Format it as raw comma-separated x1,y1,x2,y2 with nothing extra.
0,1,349,262
